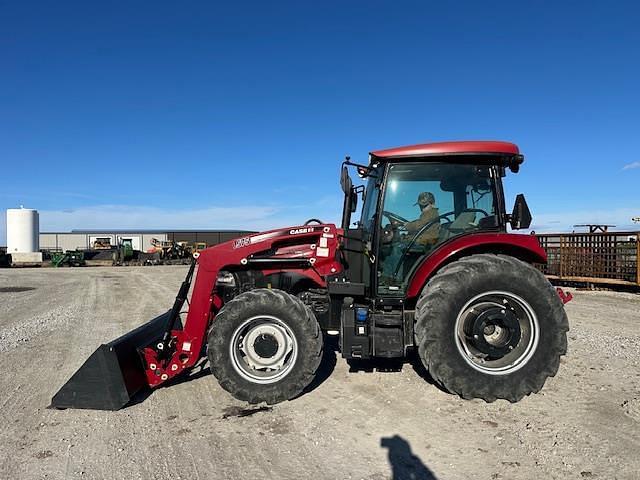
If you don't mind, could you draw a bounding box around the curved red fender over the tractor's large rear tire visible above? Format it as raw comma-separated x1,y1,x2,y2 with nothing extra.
407,233,547,300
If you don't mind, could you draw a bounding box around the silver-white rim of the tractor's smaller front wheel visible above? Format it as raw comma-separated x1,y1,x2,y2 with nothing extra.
229,315,298,384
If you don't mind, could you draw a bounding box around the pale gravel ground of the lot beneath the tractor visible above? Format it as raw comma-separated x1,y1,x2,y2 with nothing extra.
0,267,640,480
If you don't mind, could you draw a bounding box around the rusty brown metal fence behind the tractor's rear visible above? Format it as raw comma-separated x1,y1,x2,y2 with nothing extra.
537,232,640,286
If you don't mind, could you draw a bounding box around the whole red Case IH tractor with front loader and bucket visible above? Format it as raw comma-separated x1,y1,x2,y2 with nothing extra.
52,142,569,410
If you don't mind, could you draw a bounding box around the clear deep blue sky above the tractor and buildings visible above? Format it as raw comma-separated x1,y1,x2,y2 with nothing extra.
0,1,640,240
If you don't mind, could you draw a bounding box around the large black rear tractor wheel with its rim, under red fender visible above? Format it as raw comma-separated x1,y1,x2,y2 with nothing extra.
415,254,569,402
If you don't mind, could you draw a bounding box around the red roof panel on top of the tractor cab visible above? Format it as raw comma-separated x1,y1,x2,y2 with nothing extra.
370,141,520,160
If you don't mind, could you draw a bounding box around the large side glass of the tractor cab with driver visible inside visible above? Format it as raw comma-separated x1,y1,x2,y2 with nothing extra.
378,163,497,294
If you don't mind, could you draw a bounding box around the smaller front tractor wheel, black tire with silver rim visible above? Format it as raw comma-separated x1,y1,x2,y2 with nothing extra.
207,289,322,405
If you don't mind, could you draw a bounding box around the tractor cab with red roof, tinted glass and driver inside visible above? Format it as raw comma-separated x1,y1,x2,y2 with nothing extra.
341,142,531,297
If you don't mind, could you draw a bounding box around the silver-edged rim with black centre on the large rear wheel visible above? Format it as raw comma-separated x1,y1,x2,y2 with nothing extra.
454,291,540,375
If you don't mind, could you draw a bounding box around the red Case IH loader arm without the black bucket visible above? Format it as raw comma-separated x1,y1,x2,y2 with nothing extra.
141,224,343,387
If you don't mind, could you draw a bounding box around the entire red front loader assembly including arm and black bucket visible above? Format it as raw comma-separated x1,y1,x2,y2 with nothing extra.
51,224,343,410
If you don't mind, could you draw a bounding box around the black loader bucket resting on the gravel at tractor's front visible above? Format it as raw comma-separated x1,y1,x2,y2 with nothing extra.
51,311,171,410
